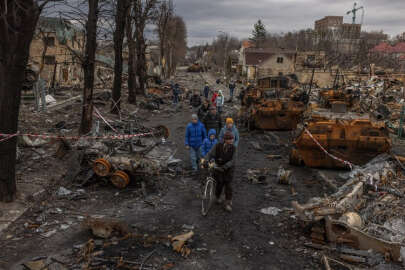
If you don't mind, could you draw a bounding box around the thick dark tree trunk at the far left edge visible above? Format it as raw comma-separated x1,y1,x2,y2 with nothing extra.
0,0,49,202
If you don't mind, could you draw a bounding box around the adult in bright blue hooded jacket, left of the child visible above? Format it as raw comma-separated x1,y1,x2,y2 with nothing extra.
185,114,207,172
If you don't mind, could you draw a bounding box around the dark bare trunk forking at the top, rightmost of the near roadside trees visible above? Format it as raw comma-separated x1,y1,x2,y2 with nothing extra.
132,0,158,95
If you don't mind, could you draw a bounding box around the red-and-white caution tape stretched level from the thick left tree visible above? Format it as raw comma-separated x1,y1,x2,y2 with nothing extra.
0,132,153,142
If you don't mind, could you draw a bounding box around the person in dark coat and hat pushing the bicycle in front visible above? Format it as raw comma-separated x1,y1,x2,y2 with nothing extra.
205,131,236,212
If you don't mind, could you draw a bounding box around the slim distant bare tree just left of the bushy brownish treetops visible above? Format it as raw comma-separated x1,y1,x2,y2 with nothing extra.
156,0,173,78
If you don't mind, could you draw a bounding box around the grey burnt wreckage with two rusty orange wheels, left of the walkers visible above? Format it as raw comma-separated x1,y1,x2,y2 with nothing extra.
72,121,177,188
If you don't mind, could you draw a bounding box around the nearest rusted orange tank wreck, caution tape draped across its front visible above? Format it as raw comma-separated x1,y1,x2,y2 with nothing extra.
290,118,391,168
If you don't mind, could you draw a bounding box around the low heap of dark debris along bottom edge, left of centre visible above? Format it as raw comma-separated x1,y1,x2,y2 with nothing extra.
22,226,194,270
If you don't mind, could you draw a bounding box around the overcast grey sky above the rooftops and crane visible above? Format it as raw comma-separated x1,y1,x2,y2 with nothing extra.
174,0,405,46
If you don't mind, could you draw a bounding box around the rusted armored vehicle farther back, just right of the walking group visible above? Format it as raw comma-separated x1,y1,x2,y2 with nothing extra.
242,76,305,130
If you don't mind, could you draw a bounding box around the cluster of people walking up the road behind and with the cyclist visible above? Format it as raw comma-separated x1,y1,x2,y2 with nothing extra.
185,81,239,212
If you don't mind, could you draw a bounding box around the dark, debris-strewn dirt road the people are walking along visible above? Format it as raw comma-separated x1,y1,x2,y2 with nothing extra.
0,73,328,270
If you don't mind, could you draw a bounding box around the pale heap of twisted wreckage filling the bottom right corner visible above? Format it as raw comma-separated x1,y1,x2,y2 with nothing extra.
292,154,405,265
